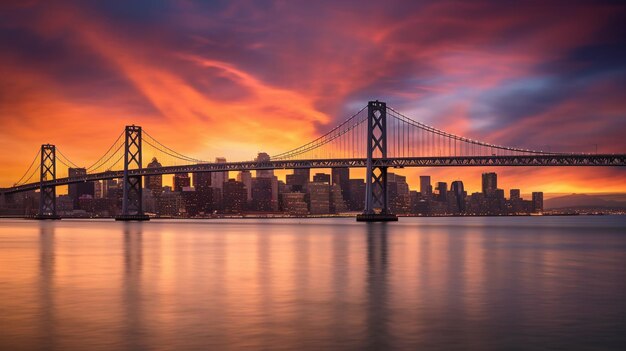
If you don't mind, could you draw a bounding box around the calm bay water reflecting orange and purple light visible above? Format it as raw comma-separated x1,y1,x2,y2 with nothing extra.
0,216,626,350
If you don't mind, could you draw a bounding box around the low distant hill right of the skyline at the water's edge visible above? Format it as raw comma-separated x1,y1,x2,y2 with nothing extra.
543,194,626,209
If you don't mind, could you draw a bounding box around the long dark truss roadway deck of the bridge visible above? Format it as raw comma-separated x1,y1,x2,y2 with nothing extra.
0,154,626,194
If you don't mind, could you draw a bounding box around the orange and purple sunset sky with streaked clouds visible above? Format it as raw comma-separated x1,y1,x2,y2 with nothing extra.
0,0,626,193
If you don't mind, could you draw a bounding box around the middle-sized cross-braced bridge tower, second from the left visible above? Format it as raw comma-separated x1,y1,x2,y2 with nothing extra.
115,125,149,221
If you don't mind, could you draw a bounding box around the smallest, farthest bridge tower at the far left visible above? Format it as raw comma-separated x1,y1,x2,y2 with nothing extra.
35,144,61,219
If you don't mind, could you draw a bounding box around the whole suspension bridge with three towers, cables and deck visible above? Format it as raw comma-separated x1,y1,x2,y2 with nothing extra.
0,101,626,221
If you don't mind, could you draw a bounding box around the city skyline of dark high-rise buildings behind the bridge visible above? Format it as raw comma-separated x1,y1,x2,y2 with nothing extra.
0,157,544,218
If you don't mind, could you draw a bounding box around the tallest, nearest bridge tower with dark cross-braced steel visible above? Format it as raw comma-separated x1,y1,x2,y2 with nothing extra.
356,100,398,222
